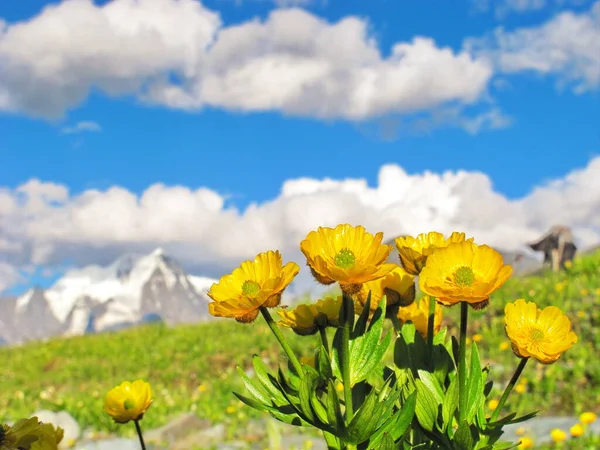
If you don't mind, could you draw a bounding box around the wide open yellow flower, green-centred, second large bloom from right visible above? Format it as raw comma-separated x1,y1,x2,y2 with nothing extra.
419,241,512,307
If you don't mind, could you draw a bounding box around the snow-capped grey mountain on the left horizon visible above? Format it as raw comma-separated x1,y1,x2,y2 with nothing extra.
0,249,216,343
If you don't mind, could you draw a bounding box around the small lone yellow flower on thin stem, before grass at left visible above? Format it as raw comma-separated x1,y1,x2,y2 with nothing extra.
104,380,152,423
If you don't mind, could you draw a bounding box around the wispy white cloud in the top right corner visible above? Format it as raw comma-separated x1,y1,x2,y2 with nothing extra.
467,2,600,92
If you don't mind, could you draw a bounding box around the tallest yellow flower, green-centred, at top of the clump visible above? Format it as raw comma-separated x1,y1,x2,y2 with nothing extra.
300,224,395,294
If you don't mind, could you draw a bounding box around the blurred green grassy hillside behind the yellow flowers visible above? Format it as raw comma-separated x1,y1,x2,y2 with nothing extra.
0,252,600,446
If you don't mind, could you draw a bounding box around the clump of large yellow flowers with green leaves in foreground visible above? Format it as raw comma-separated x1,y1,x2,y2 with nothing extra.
200,224,577,450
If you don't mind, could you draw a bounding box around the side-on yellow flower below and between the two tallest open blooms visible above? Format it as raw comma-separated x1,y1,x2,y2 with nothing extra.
357,265,416,311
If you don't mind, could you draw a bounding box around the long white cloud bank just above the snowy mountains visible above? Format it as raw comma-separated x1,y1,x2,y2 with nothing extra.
0,157,600,296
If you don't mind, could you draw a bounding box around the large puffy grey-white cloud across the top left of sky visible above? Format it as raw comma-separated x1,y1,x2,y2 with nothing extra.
0,0,492,125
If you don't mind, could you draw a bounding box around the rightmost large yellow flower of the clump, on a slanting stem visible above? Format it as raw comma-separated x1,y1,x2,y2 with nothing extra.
504,299,577,364
